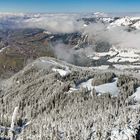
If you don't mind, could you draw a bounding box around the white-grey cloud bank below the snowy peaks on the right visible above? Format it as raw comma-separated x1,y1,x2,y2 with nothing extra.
84,23,140,48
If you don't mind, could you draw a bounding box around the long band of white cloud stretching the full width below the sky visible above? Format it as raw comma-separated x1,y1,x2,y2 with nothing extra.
0,13,140,48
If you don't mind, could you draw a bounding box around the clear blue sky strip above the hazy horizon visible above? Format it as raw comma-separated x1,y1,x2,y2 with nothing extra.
0,0,140,12
